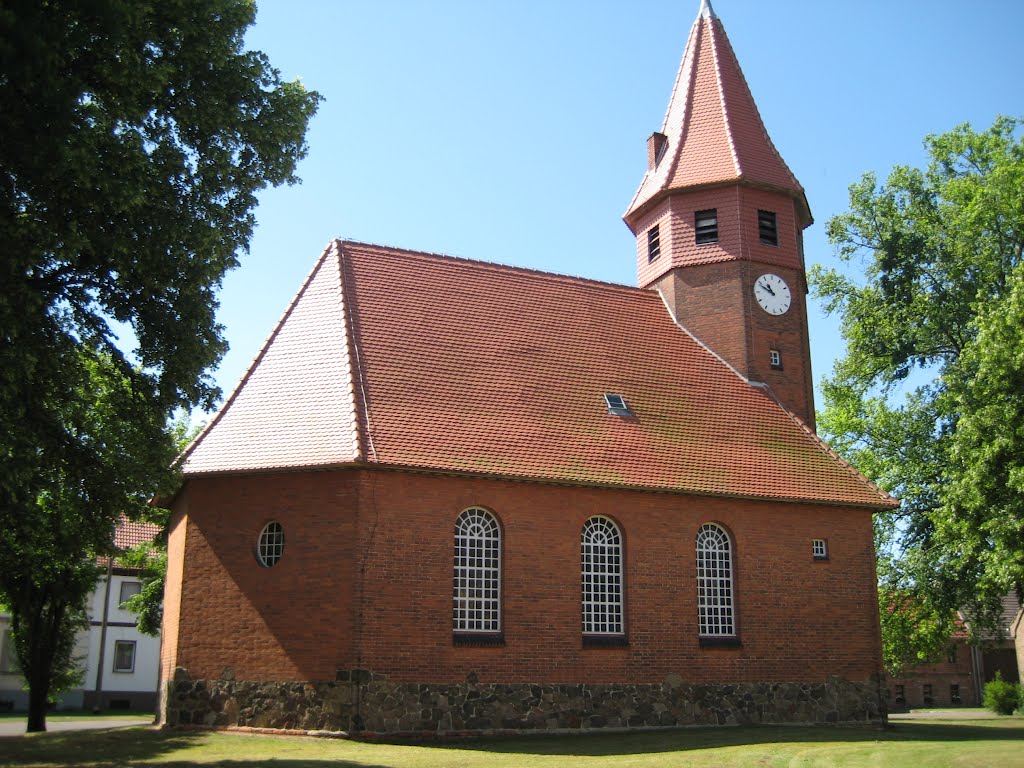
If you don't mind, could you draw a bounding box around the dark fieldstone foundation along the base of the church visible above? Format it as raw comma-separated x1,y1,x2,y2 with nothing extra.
162,669,886,736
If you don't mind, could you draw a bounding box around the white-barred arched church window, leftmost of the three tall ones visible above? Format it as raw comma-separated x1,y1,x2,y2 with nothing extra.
452,507,502,632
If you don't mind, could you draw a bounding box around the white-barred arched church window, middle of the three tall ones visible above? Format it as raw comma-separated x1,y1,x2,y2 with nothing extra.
580,517,624,635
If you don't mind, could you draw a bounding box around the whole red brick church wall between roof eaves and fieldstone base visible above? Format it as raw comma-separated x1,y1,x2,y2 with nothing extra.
165,471,881,683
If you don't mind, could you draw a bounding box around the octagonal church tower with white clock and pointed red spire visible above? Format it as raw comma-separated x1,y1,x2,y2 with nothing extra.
624,0,814,429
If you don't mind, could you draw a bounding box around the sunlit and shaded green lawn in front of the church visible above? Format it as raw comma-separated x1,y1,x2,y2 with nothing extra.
0,716,1024,768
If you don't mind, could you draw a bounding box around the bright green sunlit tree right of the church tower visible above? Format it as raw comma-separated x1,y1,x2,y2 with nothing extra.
811,118,1024,669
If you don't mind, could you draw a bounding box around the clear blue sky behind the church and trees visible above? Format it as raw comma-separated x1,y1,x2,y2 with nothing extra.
207,0,1024,407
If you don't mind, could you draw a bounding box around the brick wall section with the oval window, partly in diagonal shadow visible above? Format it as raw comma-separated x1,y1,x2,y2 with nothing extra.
165,472,358,681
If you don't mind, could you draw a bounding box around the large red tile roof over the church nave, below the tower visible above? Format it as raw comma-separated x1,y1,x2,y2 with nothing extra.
184,242,893,508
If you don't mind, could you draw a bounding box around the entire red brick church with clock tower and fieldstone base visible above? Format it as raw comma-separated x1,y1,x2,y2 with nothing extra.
157,2,894,733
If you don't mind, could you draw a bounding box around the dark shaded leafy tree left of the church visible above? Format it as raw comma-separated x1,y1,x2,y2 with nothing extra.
0,0,319,730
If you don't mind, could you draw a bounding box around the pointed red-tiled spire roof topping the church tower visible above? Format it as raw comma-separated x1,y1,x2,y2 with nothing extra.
625,0,811,226
